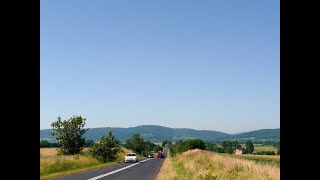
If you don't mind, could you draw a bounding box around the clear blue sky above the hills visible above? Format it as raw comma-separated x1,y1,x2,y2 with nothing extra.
40,0,280,133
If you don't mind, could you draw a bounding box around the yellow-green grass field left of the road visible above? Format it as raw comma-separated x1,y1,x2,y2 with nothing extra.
40,148,131,179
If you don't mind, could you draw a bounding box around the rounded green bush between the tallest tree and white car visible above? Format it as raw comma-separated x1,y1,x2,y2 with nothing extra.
90,131,120,162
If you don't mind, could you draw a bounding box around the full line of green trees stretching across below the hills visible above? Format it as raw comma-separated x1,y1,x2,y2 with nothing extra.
40,116,280,156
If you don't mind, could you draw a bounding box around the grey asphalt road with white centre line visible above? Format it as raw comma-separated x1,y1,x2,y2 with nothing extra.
55,148,167,180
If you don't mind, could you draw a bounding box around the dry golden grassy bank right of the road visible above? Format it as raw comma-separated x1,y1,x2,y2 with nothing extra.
157,149,280,180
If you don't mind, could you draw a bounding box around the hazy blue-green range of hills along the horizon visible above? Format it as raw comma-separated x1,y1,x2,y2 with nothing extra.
40,125,280,142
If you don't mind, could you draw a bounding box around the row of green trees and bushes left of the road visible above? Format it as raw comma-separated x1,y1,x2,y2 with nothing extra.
40,116,162,162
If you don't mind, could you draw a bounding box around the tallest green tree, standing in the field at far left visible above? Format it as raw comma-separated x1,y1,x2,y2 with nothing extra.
51,116,88,155
